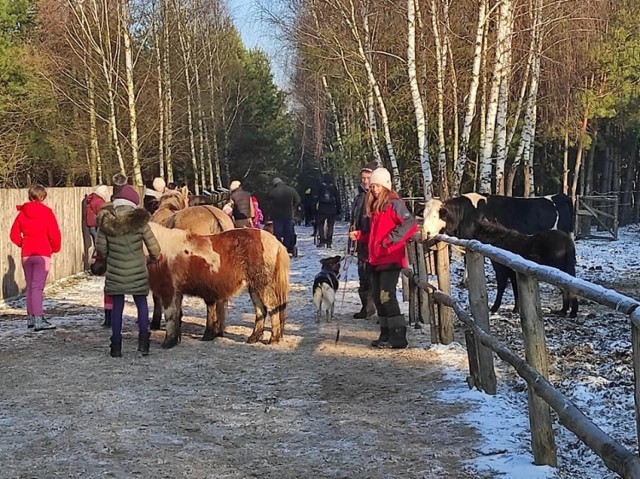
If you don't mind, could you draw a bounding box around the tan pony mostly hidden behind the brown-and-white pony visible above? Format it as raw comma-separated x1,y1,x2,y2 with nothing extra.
150,189,234,332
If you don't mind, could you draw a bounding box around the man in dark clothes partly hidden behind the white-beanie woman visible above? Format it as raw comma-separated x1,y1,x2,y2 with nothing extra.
349,163,376,319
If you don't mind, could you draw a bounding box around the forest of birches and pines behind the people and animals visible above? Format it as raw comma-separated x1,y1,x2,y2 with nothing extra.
0,0,640,221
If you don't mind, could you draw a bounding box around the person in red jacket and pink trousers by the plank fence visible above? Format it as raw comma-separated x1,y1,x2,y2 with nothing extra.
9,185,61,331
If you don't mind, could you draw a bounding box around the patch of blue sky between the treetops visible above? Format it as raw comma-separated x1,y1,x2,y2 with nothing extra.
227,0,286,88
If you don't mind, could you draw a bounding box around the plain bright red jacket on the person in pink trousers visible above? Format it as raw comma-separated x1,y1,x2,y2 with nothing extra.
9,201,61,258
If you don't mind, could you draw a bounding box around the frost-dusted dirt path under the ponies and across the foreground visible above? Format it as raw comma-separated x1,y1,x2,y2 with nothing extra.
0,232,479,479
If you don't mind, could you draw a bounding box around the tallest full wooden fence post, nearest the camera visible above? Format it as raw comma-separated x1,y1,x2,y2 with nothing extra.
517,273,558,467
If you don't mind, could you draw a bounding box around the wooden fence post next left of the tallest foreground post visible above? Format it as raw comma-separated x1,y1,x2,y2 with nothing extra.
467,250,497,394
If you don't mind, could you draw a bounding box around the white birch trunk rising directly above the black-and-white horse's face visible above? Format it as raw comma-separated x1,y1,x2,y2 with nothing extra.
407,0,433,201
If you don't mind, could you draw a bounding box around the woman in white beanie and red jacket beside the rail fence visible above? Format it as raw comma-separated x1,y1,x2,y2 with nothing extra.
349,168,418,349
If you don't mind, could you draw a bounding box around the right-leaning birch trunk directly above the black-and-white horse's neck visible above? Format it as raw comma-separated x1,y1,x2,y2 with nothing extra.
451,0,487,196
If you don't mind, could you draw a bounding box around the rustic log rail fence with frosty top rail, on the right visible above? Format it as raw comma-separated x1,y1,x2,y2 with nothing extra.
403,235,640,479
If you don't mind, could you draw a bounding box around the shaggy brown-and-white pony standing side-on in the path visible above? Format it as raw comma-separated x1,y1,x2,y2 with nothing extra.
149,223,289,348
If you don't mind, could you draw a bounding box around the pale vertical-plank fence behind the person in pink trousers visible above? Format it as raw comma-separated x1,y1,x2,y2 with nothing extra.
0,187,99,299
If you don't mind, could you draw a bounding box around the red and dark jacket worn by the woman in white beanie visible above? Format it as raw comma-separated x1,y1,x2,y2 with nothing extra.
357,194,418,269
